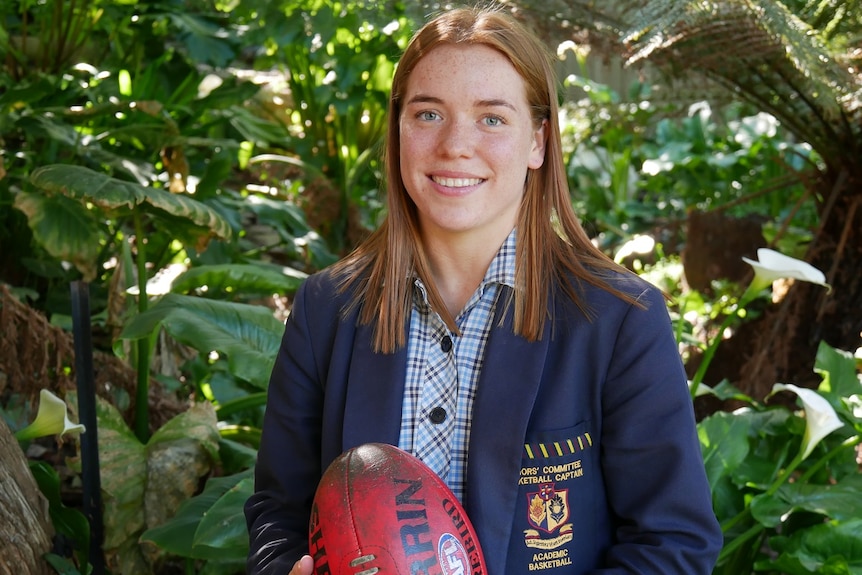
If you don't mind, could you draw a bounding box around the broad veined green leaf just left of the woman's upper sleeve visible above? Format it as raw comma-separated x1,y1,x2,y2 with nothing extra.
115,294,284,389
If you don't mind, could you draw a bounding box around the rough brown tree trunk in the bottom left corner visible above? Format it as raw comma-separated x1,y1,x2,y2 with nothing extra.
0,419,54,575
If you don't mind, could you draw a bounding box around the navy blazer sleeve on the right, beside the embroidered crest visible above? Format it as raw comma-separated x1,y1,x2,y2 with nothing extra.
599,287,722,575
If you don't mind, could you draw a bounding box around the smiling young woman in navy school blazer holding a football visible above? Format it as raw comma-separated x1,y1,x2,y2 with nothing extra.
246,5,722,575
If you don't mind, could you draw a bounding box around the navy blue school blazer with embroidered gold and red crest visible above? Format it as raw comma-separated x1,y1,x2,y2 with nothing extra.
245,272,722,575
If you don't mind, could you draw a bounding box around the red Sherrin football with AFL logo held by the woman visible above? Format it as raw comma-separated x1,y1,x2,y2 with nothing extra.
308,443,486,575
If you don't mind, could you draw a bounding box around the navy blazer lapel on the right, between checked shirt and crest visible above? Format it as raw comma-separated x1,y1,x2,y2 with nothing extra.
465,290,551,573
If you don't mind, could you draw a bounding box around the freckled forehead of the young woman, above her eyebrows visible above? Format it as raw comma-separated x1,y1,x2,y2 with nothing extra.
407,44,525,97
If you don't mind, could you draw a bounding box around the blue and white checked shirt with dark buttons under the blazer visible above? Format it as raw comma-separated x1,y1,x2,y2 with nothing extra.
398,230,515,500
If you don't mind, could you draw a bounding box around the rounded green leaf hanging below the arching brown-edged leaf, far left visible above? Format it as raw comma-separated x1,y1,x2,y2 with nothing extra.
15,191,101,281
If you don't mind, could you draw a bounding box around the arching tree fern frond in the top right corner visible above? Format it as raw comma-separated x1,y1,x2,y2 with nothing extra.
624,0,862,169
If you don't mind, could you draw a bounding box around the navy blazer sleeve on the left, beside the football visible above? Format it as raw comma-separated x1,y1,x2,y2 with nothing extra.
245,281,323,575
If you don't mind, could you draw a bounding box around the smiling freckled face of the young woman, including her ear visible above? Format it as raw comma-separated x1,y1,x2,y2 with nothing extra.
399,44,545,245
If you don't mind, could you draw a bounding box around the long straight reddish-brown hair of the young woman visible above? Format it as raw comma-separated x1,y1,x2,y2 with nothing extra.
332,4,636,353
